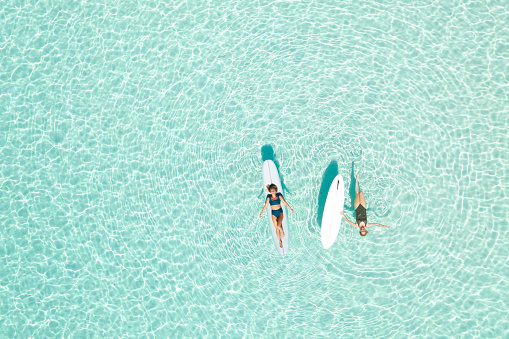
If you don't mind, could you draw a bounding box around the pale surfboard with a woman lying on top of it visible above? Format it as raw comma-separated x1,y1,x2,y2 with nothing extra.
263,160,290,256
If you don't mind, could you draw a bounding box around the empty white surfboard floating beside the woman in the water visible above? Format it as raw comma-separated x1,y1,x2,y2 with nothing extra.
321,174,345,248
